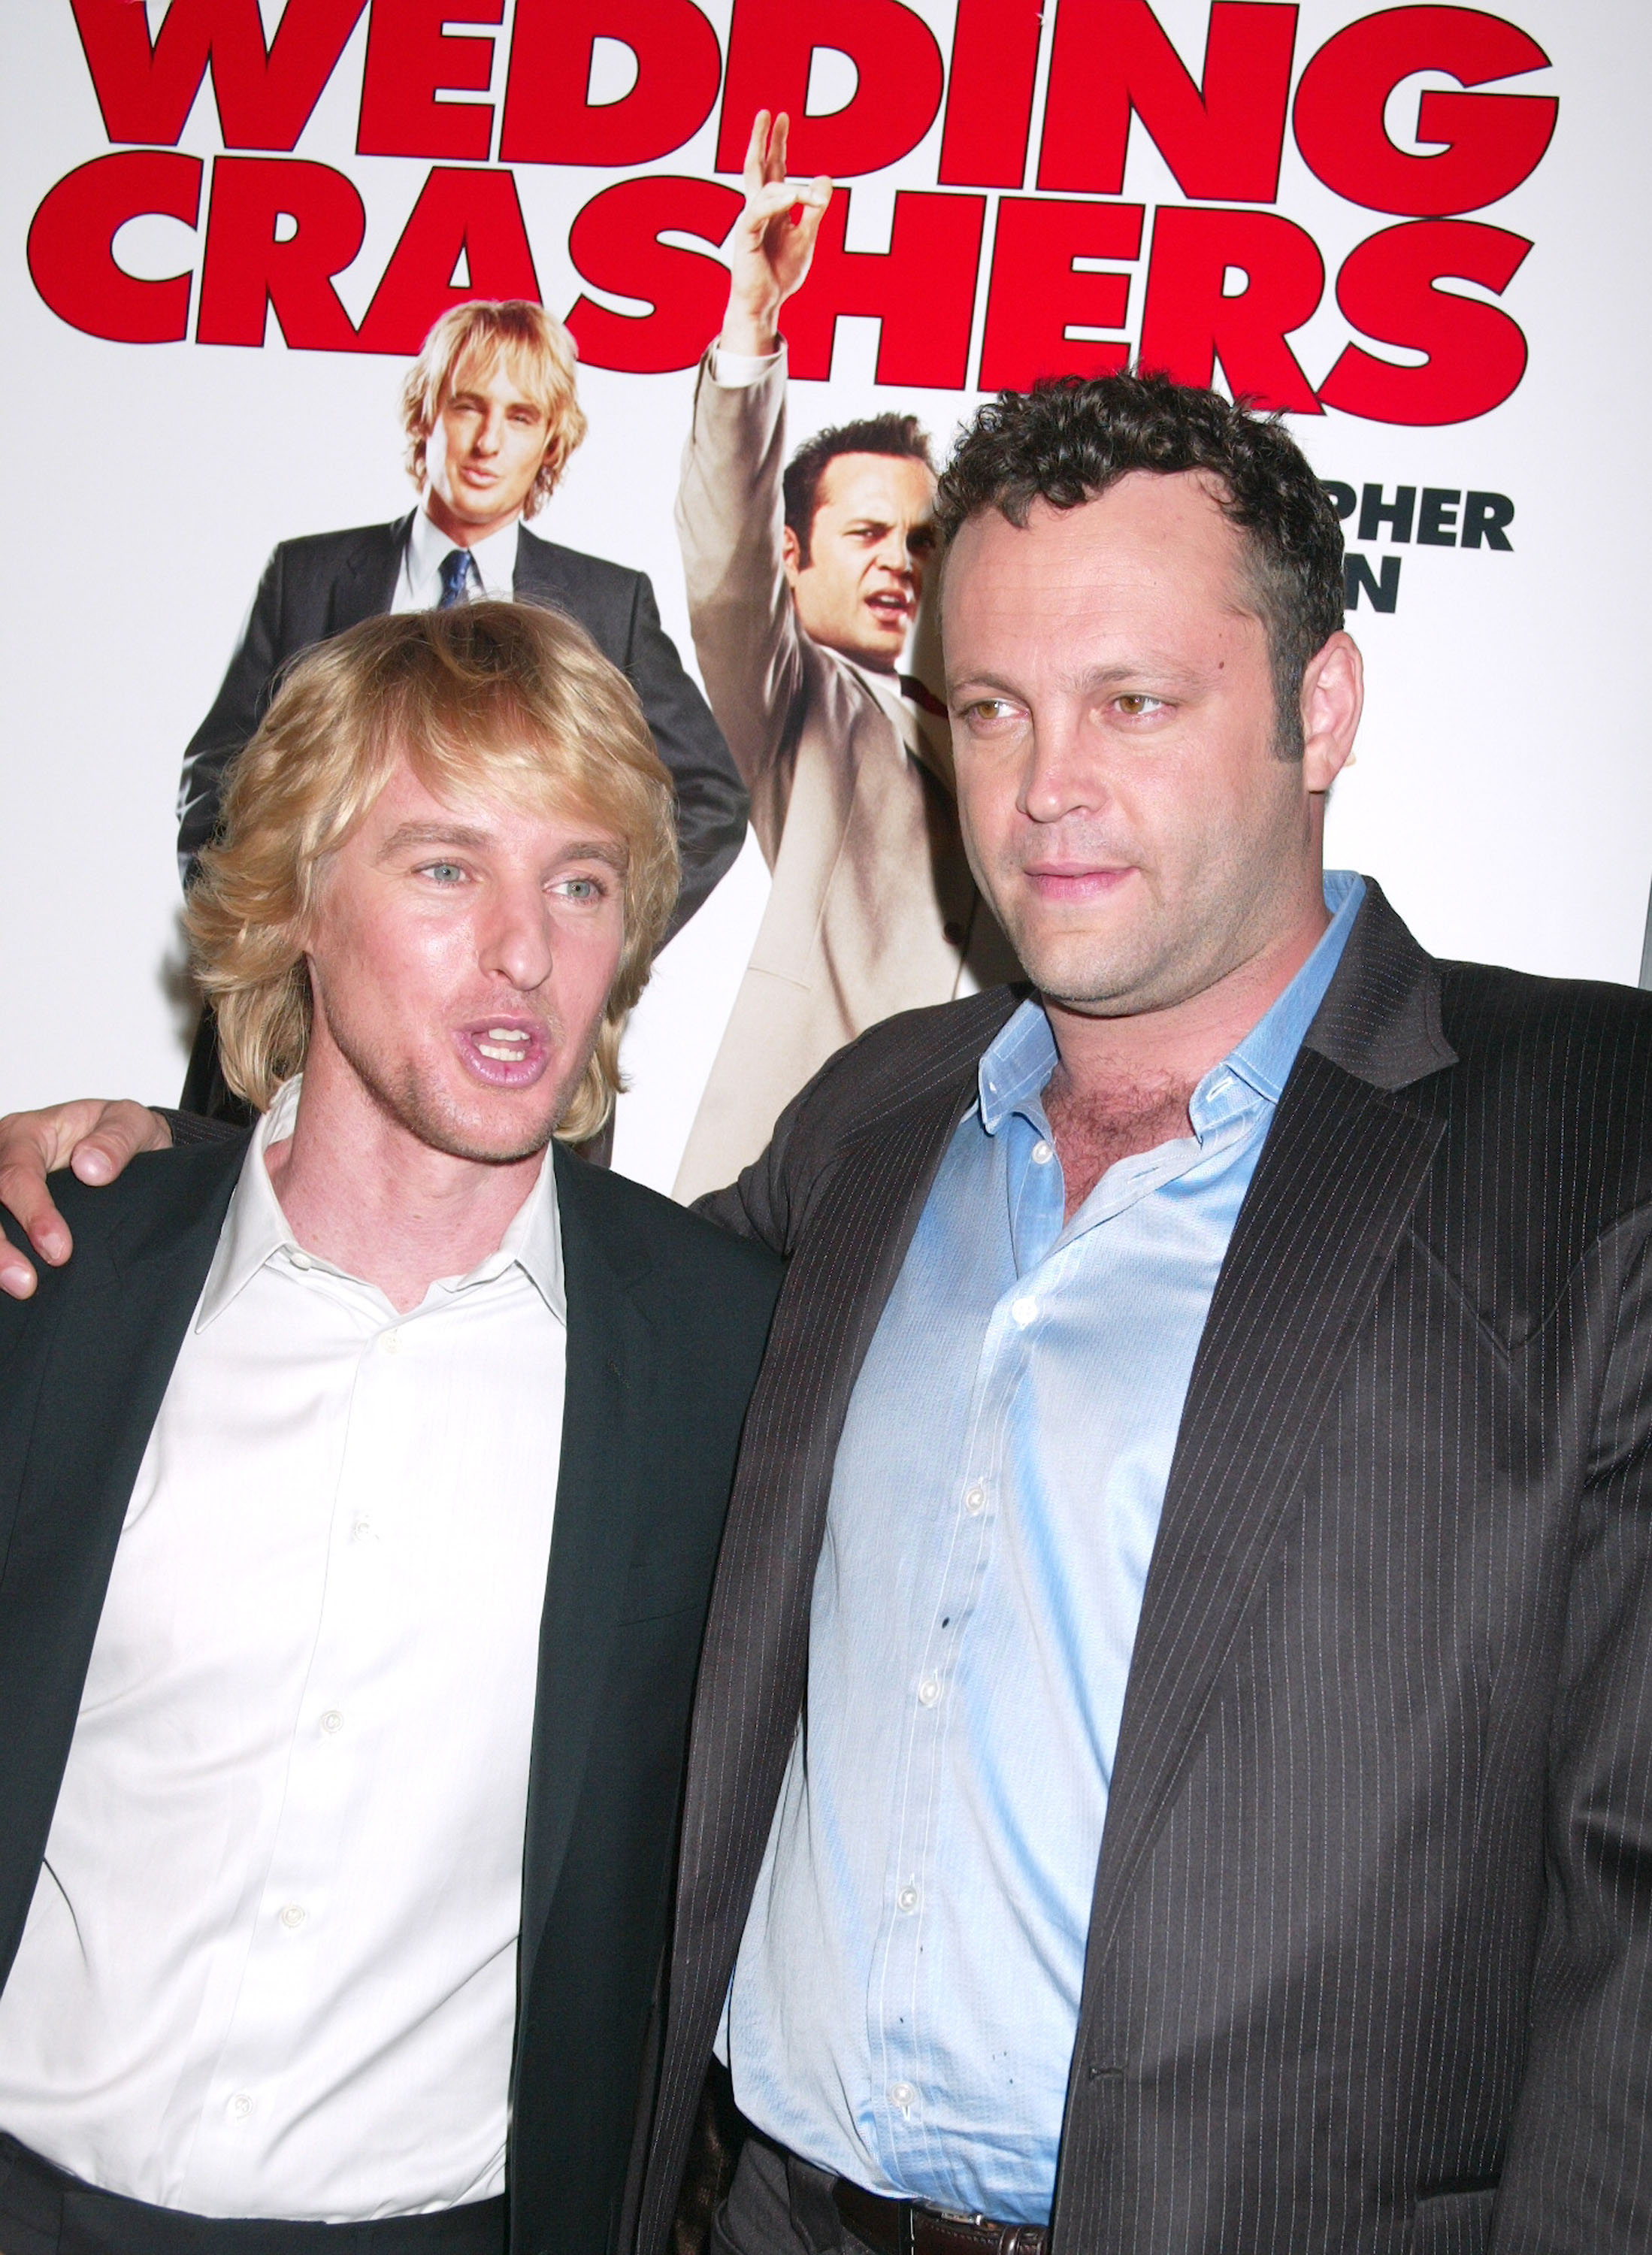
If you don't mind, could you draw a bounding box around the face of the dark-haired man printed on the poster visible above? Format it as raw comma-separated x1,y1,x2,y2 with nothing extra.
787,453,935,674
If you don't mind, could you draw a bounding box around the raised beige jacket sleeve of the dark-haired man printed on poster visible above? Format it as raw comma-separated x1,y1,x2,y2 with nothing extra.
676,356,805,868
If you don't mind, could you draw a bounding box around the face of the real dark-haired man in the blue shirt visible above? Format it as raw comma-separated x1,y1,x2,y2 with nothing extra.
942,471,1359,1017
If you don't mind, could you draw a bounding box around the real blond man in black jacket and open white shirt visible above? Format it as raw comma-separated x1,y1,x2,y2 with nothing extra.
0,602,778,2255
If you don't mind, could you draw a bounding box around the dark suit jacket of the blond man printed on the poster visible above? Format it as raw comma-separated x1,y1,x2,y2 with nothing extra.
178,516,749,931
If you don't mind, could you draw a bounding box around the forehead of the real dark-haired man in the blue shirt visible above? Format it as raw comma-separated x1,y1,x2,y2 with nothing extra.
942,471,1260,665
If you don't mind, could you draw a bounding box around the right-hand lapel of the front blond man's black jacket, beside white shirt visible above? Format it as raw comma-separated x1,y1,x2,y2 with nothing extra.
521,1146,654,1998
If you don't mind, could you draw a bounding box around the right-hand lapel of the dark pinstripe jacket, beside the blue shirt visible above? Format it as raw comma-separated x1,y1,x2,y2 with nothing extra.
1086,886,1456,1984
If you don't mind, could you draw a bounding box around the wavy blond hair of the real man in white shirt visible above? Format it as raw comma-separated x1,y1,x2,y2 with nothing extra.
185,602,676,1143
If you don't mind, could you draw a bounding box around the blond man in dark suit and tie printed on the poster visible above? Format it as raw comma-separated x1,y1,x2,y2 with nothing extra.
178,300,746,1128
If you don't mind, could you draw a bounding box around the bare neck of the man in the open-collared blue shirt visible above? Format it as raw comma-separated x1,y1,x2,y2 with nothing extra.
1043,895,1330,1220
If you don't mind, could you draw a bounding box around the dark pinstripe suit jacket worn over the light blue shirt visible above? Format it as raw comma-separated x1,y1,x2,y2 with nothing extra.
640,886,1652,2255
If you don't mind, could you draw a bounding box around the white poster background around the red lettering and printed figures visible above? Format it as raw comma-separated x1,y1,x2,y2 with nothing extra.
0,0,1652,1186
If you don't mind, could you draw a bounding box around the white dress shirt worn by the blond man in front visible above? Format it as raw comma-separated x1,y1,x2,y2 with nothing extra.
0,1085,566,2221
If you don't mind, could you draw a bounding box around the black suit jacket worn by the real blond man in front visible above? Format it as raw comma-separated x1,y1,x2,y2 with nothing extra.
0,1137,778,2255
